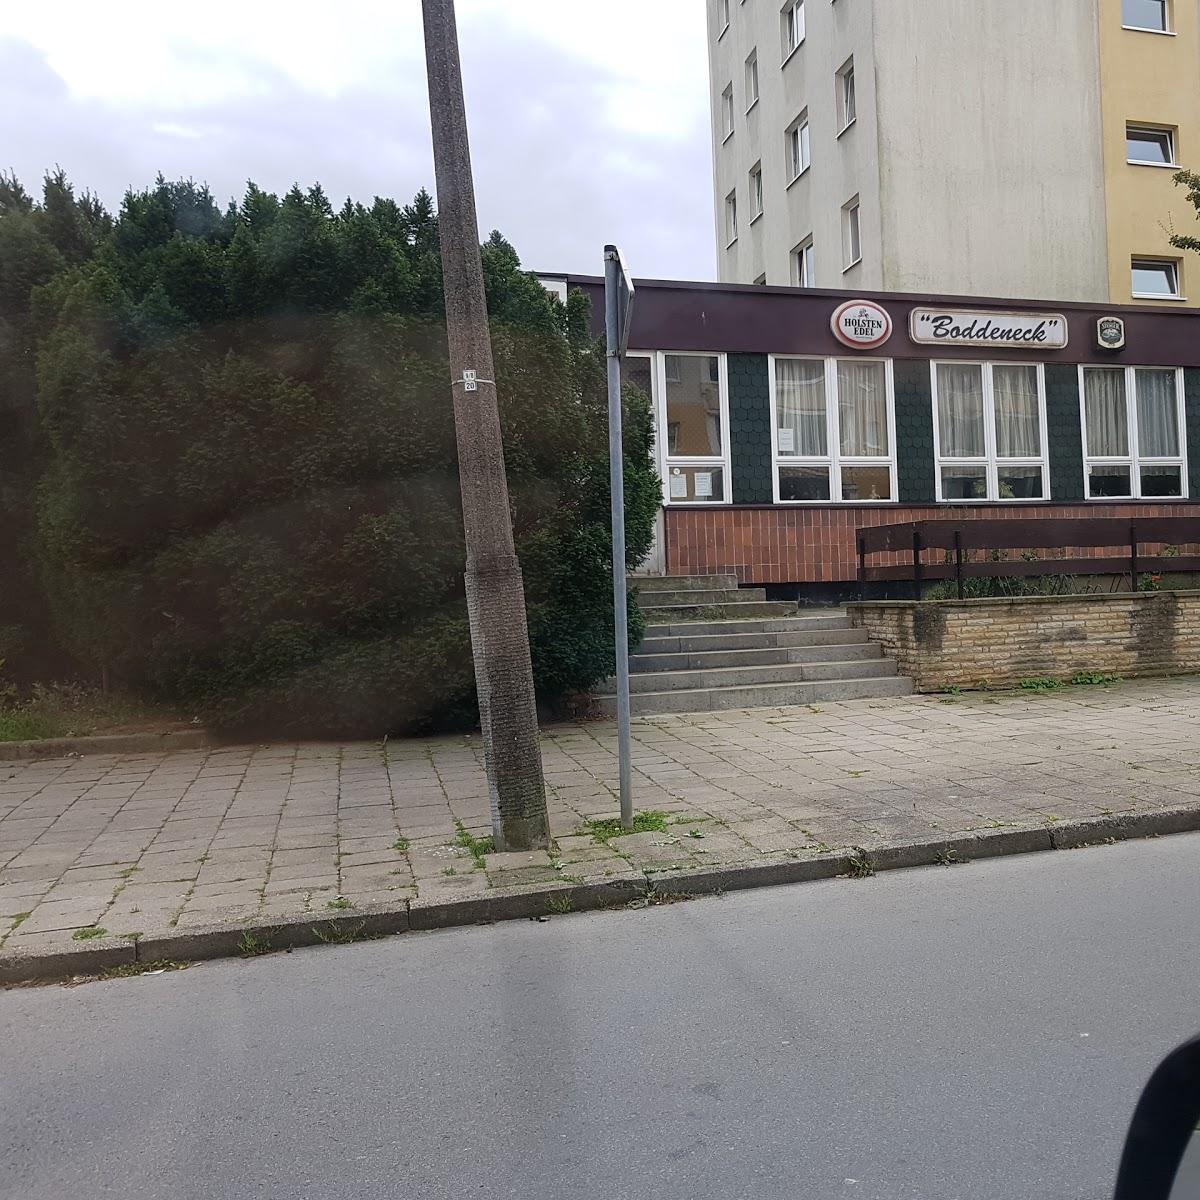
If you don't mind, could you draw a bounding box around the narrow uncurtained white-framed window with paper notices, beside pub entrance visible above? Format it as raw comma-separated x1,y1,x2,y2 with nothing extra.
660,354,728,504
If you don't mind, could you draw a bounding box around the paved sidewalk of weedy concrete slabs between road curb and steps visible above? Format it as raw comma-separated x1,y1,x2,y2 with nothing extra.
0,678,1200,962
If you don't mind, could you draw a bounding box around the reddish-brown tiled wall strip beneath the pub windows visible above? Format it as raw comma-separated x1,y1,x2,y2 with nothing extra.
664,503,1200,583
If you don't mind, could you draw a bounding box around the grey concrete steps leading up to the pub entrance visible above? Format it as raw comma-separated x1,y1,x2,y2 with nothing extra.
596,575,912,715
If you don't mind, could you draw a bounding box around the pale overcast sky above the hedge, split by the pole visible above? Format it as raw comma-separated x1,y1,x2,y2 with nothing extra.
0,0,714,280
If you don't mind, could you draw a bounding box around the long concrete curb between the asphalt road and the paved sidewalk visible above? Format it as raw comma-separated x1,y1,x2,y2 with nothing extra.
0,804,1200,985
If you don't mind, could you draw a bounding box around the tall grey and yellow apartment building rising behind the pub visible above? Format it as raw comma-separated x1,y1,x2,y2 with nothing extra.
706,0,1200,307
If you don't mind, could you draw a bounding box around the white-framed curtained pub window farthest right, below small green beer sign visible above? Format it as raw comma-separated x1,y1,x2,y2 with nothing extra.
1079,367,1187,500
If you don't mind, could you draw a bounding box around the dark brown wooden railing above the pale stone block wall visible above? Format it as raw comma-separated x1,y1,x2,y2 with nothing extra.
858,517,1200,599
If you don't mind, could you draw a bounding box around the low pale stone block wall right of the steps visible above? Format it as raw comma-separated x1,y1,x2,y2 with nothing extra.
847,592,1200,691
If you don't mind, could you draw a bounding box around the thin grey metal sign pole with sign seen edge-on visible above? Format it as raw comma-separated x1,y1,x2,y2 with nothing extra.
604,246,634,829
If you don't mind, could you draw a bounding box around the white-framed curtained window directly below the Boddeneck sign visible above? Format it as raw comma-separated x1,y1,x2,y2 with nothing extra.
934,362,1049,500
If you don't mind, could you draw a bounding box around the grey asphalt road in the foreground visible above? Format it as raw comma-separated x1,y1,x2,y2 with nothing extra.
0,835,1200,1200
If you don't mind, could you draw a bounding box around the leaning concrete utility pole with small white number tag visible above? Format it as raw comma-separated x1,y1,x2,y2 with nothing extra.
421,0,550,850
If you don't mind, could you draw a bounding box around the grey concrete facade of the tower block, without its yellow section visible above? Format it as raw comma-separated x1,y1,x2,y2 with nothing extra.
707,0,1109,301
